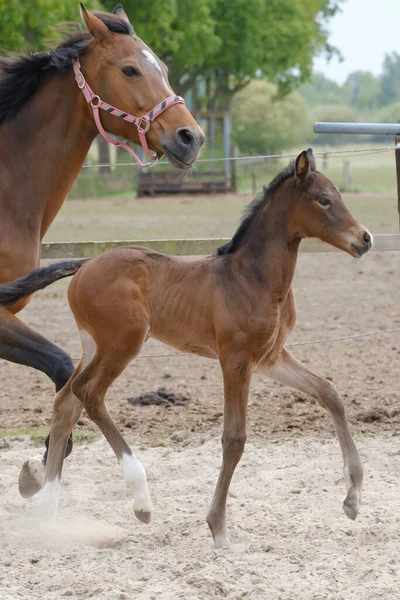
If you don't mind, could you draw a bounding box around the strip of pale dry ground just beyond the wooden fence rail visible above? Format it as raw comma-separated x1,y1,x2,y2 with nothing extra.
42,194,399,246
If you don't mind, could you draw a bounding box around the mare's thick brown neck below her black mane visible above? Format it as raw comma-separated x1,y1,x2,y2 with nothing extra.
0,67,97,238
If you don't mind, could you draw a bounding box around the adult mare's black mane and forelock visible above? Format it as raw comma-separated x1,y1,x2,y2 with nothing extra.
0,12,133,125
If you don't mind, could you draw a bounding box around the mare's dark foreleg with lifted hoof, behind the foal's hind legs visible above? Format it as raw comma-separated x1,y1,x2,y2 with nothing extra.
0,308,74,498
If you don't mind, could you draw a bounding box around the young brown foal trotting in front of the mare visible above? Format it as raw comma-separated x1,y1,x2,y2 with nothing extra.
0,150,372,547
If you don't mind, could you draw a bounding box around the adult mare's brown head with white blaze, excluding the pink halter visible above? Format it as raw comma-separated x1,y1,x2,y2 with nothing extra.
81,5,204,169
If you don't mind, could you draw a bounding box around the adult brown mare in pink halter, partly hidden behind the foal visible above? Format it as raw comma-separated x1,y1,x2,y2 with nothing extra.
0,6,204,496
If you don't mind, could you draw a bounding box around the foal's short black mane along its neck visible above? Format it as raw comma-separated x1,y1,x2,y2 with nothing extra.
217,161,295,256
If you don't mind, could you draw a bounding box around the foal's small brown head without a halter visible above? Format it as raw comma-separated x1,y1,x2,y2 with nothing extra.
290,148,372,258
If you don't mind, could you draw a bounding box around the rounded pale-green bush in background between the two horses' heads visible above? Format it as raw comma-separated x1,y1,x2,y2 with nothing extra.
232,81,311,154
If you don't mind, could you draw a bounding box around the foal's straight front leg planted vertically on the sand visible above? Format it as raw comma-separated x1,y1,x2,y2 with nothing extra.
207,359,252,548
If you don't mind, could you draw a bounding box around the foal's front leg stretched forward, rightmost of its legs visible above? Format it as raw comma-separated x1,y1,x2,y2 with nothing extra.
258,348,363,519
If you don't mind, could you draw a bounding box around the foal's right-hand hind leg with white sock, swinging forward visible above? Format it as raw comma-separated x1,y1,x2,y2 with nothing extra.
72,322,152,523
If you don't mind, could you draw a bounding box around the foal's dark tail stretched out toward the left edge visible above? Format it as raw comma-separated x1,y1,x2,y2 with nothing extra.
0,258,90,306
